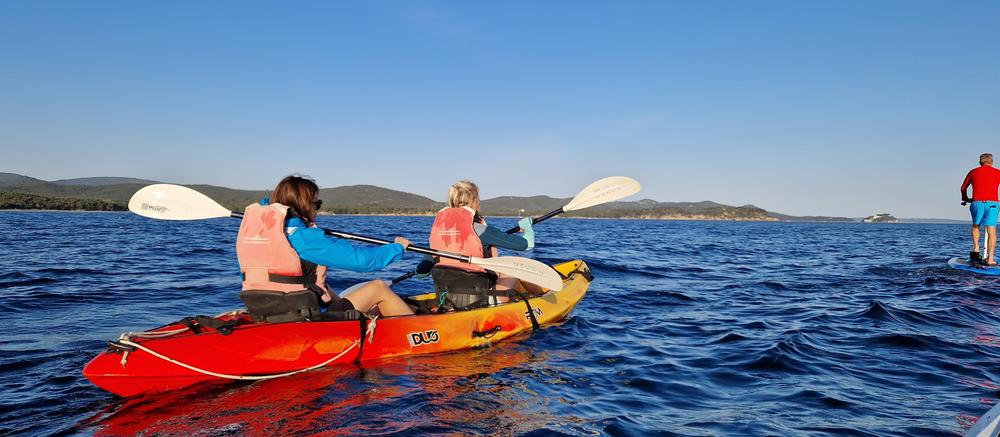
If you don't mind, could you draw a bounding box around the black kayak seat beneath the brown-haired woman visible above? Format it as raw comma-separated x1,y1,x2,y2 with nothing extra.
240,290,361,323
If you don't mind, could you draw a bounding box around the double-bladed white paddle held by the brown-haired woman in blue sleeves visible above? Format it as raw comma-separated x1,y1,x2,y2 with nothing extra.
128,184,563,291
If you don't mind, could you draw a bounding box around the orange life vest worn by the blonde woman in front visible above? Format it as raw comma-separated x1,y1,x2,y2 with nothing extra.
430,207,496,272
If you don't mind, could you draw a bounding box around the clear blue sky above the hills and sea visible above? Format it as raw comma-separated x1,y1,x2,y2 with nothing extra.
0,0,1000,218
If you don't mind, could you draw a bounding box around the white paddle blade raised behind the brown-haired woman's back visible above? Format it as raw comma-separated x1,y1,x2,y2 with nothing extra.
128,184,231,220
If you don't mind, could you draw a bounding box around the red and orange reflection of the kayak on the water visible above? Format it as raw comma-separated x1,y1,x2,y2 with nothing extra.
81,340,545,436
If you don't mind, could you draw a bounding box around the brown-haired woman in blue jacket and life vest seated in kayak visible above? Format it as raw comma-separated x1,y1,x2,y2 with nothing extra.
236,175,413,322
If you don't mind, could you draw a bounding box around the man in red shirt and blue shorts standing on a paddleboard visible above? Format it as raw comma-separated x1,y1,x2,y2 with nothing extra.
962,153,1000,267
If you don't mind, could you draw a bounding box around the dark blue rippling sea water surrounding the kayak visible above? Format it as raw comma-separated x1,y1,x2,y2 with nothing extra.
0,212,1000,436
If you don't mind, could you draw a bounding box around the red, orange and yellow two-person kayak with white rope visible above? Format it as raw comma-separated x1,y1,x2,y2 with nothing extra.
83,260,593,397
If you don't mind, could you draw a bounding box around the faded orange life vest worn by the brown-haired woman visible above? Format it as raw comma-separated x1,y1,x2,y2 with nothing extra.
236,203,329,294
